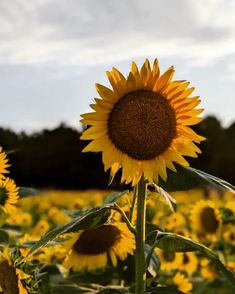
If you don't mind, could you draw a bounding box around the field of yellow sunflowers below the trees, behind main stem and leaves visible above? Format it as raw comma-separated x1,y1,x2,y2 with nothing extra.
0,186,235,293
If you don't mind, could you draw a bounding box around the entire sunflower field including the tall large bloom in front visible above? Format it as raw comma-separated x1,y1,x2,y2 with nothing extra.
0,60,235,294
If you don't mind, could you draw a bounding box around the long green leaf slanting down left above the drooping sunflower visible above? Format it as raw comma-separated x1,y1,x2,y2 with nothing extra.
25,205,112,258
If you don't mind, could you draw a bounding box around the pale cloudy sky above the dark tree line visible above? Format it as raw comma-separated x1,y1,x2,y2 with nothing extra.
0,0,235,132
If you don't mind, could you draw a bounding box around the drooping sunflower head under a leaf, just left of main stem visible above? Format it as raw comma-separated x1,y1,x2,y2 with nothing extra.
63,222,135,271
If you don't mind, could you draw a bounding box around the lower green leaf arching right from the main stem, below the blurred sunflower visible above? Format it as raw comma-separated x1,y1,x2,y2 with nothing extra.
155,232,235,287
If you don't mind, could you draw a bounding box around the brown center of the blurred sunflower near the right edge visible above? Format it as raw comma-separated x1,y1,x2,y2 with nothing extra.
200,207,219,234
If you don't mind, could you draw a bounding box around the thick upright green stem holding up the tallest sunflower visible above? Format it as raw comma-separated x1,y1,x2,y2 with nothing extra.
135,177,146,294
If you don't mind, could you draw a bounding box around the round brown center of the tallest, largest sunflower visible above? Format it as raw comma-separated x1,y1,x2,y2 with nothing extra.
108,90,176,160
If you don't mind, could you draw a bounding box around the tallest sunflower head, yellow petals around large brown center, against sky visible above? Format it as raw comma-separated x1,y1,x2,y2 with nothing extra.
81,60,204,185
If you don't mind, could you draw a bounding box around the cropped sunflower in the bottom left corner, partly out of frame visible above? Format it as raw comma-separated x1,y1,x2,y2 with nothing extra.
0,248,30,294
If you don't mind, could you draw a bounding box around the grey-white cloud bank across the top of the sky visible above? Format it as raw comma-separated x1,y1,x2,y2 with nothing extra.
0,0,235,66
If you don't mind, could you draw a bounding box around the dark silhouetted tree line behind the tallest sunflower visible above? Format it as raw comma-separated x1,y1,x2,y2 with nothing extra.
0,116,235,189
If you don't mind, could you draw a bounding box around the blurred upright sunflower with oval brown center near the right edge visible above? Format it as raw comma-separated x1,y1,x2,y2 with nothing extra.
191,200,222,242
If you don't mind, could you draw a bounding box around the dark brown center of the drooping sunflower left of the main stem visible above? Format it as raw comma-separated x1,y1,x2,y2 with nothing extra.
73,225,120,255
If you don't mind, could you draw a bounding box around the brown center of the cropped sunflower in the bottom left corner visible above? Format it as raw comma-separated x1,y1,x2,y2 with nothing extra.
0,260,19,294
